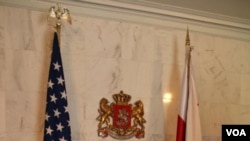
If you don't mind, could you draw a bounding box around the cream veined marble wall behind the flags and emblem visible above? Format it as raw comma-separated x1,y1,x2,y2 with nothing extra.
0,6,250,141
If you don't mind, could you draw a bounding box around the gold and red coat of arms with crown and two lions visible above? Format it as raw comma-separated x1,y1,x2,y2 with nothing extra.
97,91,146,139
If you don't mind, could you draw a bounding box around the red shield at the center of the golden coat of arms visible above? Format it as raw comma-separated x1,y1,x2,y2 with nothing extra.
113,104,132,129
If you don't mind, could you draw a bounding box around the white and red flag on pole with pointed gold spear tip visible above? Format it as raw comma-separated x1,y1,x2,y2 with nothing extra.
176,31,202,141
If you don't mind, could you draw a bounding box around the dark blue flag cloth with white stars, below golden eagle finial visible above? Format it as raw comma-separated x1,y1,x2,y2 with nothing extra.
44,33,71,141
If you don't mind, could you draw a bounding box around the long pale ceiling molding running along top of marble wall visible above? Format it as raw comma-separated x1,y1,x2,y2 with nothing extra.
0,0,250,41
